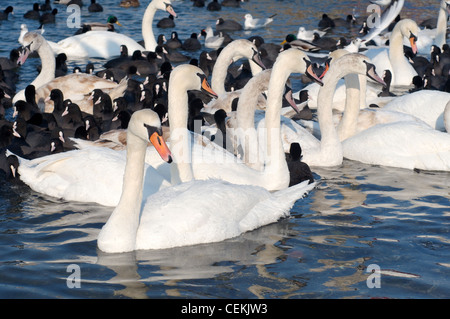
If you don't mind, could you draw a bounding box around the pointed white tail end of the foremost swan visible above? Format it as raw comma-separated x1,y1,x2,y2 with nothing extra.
239,181,316,232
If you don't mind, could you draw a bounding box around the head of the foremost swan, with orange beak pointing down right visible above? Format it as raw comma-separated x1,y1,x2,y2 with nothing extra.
128,109,172,163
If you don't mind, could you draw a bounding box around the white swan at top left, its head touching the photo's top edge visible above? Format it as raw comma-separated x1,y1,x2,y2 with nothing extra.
50,0,176,59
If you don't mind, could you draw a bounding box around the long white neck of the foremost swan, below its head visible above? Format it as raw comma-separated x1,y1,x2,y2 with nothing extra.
98,131,147,252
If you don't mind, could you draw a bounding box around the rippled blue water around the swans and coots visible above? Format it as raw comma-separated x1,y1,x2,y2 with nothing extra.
0,0,450,300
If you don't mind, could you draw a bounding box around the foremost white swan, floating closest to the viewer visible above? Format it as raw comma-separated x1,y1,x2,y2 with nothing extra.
97,99,314,253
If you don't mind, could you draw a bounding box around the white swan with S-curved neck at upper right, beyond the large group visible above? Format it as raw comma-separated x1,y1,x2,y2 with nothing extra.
364,19,419,86
